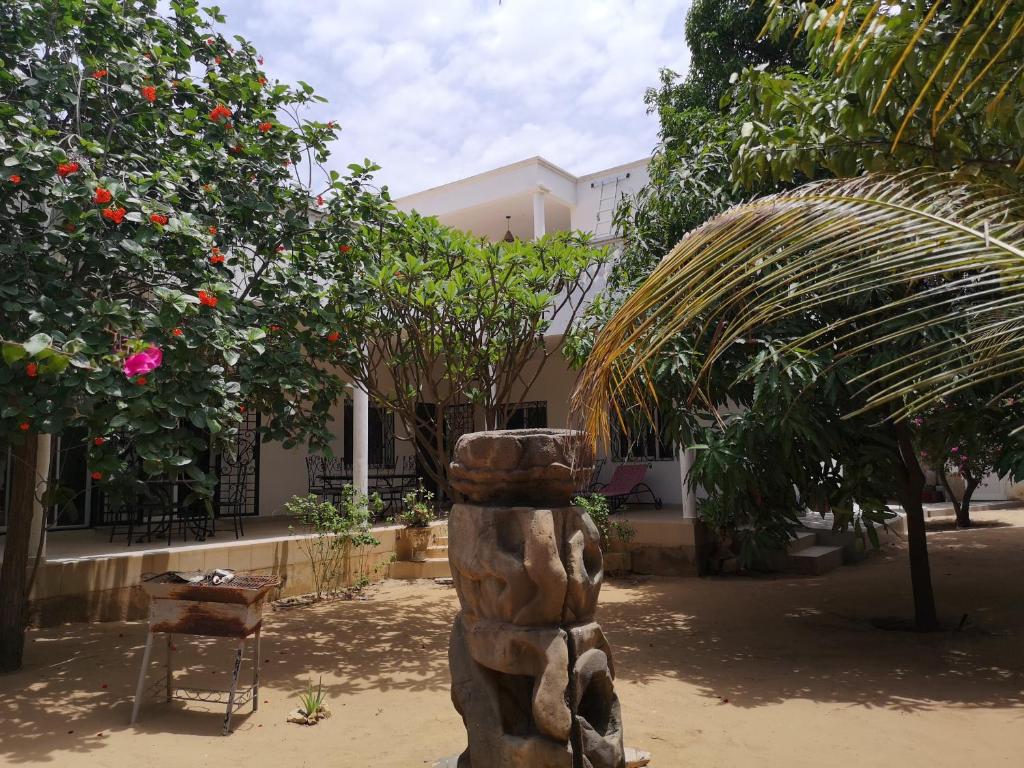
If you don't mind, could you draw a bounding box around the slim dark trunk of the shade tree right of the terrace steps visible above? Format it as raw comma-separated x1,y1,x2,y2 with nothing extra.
895,422,939,632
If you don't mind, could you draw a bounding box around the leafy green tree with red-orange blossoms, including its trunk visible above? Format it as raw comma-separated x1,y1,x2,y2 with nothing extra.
0,0,385,670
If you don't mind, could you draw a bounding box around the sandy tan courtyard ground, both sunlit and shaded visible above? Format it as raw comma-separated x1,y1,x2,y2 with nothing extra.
0,509,1024,768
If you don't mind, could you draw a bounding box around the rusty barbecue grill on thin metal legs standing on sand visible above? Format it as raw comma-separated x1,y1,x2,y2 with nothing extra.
131,570,281,736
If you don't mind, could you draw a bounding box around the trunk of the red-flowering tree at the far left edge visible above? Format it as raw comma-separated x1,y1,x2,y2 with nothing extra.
0,434,37,672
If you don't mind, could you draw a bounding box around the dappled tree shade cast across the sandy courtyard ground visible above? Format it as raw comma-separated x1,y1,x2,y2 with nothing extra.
0,518,1024,764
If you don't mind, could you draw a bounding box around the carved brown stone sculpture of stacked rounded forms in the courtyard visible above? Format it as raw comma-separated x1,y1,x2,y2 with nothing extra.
449,429,626,768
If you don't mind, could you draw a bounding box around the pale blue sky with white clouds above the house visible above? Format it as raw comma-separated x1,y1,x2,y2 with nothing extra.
208,0,689,197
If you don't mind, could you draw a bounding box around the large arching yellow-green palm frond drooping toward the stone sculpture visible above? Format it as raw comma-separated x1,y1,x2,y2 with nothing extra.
572,171,1024,438
